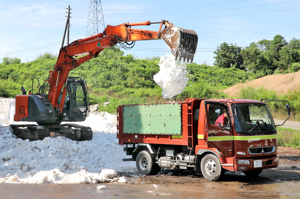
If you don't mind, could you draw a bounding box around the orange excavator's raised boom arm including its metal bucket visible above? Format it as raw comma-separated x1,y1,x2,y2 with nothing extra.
47,20,198,113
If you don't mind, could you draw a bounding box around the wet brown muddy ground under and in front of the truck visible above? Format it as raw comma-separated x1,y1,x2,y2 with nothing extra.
0,147,300,199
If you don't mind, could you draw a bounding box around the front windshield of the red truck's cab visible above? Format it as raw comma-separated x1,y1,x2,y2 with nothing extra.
232,103,276,135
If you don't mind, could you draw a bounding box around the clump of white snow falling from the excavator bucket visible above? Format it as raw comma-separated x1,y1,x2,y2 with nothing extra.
153,54,188,99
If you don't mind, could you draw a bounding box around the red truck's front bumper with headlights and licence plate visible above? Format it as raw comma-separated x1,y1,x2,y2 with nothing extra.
234,156,279,171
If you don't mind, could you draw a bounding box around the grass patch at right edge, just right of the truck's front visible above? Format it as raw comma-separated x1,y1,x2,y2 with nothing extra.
277,127,300,149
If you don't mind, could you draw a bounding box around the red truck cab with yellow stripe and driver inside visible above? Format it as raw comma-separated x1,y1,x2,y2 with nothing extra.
196,100,278,178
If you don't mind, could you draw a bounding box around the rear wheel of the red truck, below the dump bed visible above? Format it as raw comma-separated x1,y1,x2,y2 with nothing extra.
136,150,160,175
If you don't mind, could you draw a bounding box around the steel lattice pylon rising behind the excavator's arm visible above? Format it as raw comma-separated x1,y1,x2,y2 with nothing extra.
86,0,105,37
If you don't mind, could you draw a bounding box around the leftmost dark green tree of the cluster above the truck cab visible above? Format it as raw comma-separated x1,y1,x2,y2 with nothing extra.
214,42,244,69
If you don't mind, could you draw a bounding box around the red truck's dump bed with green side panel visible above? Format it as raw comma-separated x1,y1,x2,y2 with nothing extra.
117,99,200,147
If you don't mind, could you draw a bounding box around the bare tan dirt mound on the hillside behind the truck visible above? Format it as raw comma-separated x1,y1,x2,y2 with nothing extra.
223,71,300,96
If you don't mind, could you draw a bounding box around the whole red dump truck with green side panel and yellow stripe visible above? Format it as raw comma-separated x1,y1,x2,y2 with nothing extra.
117,98,290,181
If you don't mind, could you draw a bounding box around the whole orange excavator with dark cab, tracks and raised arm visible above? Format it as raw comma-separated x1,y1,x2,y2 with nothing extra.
11,20,198,141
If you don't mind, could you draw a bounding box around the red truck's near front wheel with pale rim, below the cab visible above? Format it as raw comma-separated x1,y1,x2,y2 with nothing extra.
201,154,224,181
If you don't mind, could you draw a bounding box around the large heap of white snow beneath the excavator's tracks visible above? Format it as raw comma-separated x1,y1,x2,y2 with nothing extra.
0,113,136,184
